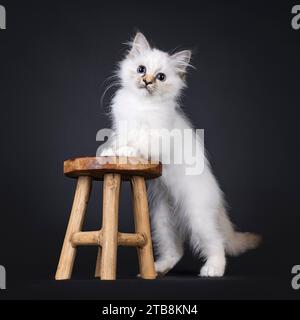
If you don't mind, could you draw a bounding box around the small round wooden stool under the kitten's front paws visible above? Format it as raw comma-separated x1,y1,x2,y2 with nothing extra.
55,157,162,280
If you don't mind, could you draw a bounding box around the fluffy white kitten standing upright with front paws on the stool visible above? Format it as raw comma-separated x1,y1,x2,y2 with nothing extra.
101,33,260,277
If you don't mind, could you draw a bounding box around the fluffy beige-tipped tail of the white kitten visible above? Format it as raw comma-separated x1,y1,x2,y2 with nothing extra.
220,209,262,256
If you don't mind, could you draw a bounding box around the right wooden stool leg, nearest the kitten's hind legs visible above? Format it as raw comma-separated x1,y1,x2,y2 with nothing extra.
131,176,156,279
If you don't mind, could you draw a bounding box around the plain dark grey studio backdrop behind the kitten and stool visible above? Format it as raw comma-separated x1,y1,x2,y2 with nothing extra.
0,0,300,298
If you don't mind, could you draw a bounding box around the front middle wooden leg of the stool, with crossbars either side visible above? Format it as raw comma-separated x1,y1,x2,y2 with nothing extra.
100,173,121,280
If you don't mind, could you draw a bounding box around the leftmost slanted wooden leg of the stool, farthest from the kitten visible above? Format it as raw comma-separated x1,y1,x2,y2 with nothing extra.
55,176,92,280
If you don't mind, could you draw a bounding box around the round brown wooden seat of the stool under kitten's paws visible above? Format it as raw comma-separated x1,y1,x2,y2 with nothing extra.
64,157,162,180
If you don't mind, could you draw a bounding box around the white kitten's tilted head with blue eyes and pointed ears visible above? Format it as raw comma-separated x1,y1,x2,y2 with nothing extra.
119,33,191,99
